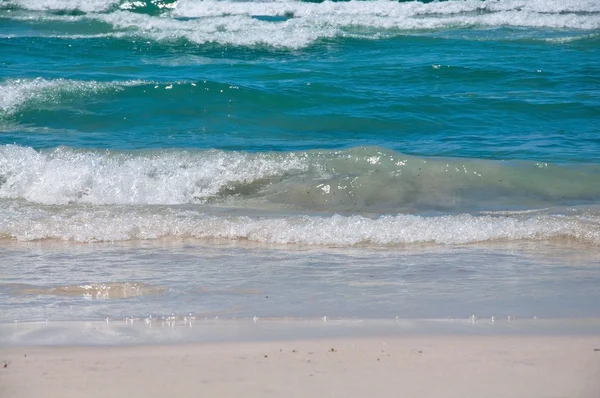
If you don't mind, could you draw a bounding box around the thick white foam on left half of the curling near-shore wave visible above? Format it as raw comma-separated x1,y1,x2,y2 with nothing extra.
0,146,308,204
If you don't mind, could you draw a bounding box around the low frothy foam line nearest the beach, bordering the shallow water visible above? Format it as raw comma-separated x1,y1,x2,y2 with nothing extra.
0,202,600,247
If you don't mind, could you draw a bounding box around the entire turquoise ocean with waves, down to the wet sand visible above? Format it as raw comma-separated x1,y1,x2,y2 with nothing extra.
0,0,600,338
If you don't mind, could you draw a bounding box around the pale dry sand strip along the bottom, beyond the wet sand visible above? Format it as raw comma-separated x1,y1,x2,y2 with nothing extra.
0,336,600,398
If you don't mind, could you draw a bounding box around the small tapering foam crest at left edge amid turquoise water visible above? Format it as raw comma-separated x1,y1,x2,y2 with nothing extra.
0,78,144,117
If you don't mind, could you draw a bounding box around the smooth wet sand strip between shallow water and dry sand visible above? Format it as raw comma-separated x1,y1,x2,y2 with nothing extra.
0,317,600,347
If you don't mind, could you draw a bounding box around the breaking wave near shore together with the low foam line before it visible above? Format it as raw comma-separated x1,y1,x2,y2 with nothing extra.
0,145,600,247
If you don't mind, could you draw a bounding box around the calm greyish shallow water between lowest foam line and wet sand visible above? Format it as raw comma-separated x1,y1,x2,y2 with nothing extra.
0,241,600,322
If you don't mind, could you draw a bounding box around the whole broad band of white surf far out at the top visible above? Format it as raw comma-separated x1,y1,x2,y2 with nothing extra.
5,0,600,48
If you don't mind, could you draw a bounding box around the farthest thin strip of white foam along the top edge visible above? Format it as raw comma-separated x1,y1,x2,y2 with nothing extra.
3,0,600,17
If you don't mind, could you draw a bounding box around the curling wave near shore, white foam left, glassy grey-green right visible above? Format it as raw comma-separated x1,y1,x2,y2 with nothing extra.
0,145,600,214
